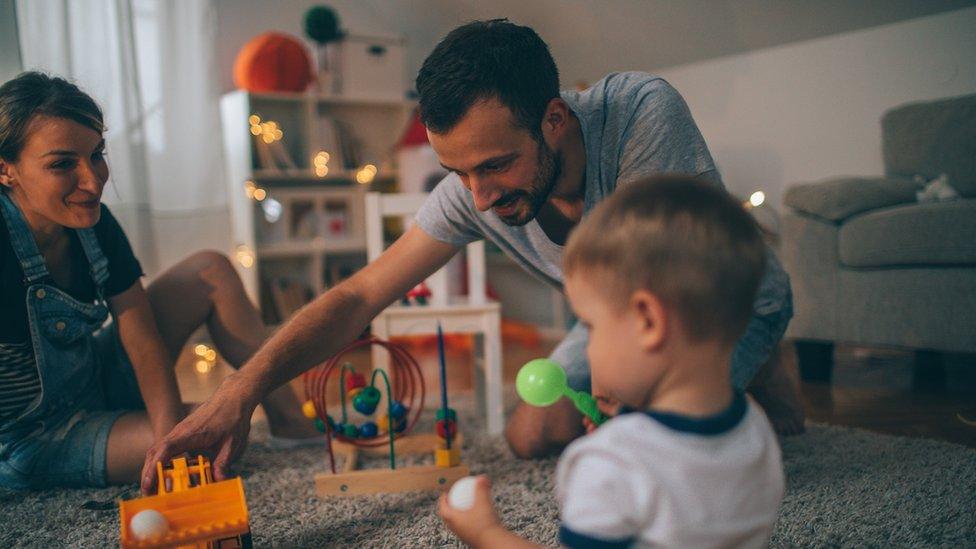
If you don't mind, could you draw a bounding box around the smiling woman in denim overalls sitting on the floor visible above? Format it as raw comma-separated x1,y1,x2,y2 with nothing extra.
0,72,314,488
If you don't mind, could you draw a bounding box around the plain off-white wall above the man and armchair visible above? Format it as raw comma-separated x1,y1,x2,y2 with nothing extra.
216,0,976,210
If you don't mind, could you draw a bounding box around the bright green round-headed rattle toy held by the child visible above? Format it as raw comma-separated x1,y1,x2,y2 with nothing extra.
515,358,607,425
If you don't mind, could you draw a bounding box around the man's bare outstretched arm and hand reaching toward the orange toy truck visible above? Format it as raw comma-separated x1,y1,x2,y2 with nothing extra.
142,225,460,494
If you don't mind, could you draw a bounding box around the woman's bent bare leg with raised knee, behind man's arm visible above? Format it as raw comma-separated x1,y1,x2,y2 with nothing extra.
146,251,318,438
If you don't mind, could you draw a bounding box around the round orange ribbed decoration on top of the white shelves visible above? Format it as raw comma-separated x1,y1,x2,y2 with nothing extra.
234,32,312,92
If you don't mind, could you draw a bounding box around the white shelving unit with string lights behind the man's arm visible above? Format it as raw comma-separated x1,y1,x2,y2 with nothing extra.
220,91,414,323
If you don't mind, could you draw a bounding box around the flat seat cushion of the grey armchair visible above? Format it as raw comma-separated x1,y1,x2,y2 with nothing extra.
838,199,976,268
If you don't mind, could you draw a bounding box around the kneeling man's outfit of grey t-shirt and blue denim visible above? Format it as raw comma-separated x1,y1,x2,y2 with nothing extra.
416,72,790,385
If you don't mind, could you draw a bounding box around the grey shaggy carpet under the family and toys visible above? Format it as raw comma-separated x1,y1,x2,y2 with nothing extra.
0,401,976,548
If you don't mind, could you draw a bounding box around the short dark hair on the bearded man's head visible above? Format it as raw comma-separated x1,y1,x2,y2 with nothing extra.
417,19,559,138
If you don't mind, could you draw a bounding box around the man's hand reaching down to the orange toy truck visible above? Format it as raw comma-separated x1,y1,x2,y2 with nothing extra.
142,374,257,495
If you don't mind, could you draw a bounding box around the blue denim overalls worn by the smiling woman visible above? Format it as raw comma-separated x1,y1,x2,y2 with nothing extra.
0,192,139,488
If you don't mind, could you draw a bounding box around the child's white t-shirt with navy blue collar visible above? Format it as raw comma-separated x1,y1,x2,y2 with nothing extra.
556,393,783,548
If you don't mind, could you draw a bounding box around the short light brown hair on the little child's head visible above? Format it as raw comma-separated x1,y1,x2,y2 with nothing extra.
563,176,766,343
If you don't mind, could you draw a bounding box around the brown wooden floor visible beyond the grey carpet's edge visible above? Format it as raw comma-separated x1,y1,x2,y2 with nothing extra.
177,340,976,448
